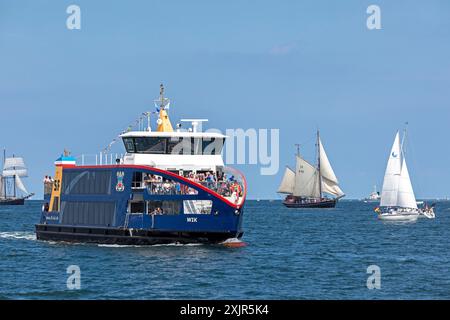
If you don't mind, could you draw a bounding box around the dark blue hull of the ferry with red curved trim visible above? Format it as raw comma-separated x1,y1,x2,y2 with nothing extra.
35,165,244,245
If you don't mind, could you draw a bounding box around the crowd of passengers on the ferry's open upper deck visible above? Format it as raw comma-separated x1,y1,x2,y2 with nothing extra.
143,172,242,199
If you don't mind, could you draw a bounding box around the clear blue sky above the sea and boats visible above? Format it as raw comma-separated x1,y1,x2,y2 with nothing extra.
0,0,450,199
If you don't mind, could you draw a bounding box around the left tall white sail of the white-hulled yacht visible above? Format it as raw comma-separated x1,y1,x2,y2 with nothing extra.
380,132,401,207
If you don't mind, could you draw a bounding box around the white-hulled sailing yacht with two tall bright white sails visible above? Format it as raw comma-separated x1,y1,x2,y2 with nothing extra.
375,132,434,221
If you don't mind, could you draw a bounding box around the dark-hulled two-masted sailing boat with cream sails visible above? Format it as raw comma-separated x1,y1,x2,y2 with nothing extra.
278,131,345,208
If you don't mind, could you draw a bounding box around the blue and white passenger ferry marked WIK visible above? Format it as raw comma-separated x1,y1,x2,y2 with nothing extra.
35,85,247,245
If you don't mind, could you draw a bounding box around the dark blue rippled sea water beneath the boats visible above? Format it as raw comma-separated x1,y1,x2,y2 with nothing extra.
0,201,450,299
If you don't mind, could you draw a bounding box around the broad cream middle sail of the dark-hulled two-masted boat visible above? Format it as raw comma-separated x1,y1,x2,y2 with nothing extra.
293,156,320,198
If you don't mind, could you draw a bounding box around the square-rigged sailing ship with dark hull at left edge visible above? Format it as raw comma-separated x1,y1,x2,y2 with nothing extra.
0,151,34,205
